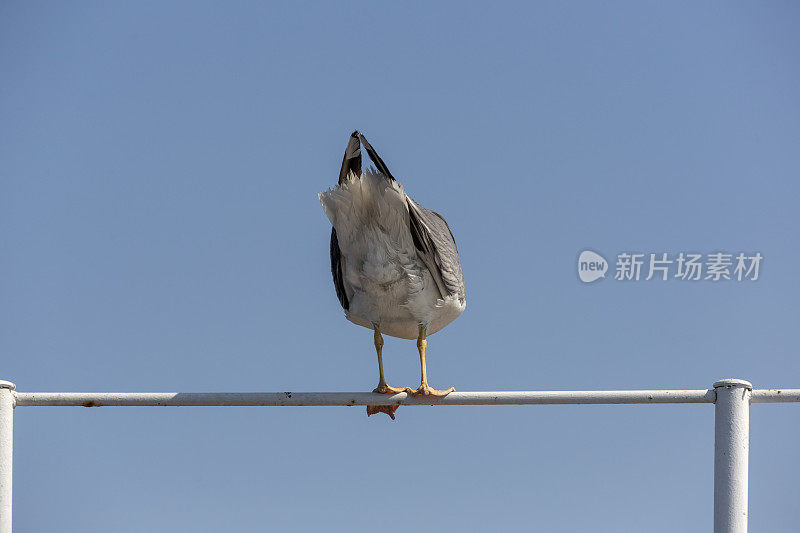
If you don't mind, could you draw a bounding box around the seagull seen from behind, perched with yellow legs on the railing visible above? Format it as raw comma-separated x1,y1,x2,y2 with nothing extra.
319,131,466,420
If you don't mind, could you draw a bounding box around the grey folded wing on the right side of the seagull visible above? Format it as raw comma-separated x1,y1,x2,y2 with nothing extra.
408,198,466,301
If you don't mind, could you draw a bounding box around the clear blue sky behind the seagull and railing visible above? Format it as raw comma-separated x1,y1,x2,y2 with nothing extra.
0,1,800,533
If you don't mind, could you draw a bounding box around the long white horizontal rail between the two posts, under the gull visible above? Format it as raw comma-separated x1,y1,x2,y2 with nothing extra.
15,389,716,407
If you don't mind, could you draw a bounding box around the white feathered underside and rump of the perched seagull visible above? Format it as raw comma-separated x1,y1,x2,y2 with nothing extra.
319,171,465,339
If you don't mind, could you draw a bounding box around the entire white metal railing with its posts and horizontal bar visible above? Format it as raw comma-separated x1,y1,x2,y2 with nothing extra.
0,379,800,533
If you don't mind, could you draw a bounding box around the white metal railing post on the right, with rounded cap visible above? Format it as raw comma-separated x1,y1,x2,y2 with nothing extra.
714,379,753,533
